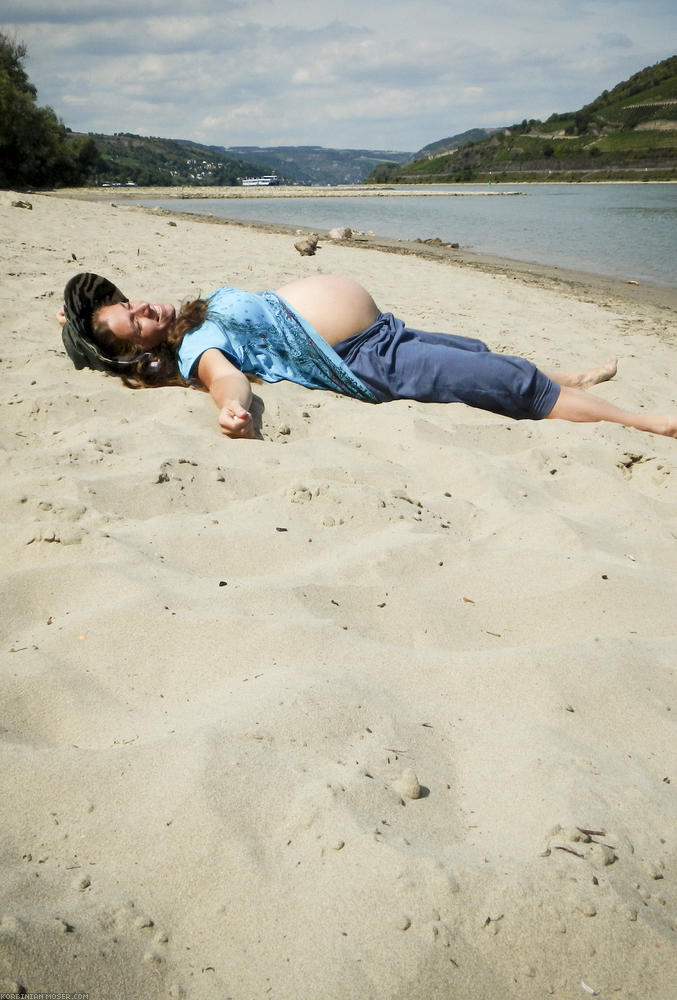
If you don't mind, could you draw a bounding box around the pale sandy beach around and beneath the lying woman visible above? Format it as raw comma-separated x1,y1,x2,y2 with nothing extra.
0,191,677,1000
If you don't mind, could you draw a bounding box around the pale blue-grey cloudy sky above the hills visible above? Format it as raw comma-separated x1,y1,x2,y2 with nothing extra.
5,0,677,151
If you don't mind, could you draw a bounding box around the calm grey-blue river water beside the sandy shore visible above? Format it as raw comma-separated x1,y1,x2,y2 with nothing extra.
141,184,677,288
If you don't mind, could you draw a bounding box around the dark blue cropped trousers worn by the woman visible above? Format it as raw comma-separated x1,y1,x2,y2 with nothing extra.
334,313,560,420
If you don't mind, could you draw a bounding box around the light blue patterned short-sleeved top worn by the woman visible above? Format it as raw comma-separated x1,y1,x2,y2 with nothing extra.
177,288,378,403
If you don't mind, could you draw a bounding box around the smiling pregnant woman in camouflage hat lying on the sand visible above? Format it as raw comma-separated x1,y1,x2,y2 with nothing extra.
57,274,677,438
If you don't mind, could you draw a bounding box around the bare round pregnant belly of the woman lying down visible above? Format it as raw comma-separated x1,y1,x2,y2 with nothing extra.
276,274,379,344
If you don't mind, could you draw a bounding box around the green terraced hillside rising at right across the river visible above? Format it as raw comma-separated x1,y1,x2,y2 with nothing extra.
367,56,677,184
